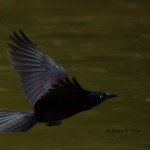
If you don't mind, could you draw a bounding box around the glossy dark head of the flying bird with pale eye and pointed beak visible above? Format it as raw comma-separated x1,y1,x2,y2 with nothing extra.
84,90,117,109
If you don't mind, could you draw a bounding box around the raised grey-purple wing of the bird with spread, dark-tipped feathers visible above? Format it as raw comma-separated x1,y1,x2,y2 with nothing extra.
7,30,67,105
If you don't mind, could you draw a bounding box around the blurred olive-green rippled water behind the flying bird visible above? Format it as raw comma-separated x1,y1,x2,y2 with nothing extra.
0,0,150,150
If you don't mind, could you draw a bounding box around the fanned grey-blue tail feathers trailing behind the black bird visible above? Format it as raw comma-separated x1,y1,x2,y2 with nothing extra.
0,110,37,132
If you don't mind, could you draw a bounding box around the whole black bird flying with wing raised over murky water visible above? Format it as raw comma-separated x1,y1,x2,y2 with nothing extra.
0,30,116,132
